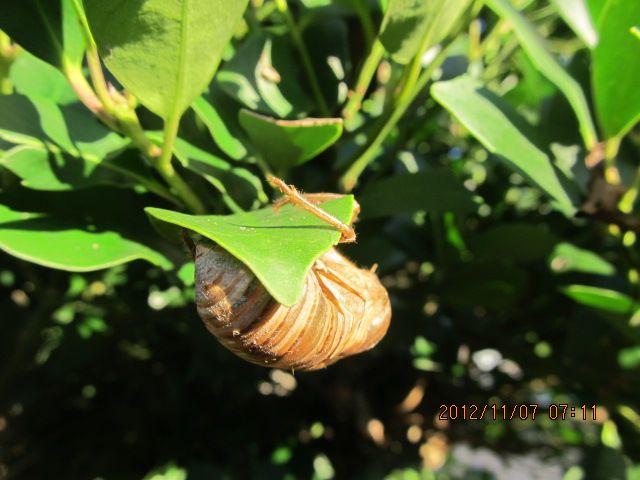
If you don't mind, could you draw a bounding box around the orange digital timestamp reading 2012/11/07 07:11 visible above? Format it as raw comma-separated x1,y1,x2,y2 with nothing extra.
438,403,597,420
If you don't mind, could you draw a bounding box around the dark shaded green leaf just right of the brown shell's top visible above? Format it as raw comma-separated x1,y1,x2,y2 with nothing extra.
358,169,474,218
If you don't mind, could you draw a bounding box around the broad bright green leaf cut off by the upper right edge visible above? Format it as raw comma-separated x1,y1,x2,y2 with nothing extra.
592,0,640,138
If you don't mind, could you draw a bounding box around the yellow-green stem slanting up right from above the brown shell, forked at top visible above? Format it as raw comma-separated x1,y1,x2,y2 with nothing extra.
340,48,448,192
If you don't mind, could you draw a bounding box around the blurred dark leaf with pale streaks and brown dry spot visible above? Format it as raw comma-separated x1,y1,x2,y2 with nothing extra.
216,31,310,118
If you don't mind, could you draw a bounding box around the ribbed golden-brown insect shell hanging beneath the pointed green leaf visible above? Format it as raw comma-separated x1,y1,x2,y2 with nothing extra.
195,243,391,370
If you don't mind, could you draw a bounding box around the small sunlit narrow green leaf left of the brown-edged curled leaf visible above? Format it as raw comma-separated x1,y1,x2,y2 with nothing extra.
192,92,247,160
